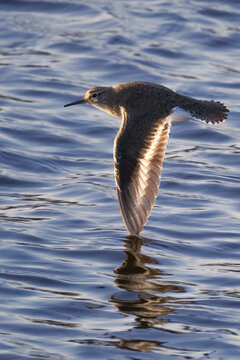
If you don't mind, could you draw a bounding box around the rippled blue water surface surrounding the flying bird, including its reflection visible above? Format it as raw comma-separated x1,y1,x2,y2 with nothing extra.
0,0,240,360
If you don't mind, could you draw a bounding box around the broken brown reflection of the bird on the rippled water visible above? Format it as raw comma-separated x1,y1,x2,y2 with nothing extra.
110,236,185,352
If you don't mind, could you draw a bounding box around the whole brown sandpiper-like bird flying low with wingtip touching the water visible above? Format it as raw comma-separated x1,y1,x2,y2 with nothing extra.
64,81,229,235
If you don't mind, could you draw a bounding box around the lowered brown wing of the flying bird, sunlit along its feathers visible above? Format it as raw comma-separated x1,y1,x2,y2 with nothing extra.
114,109,171,235
